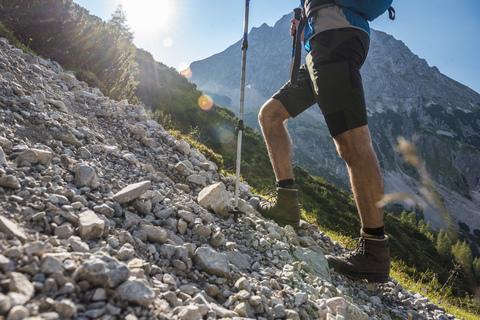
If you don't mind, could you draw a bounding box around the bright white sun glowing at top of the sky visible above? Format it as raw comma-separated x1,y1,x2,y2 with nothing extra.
122,0,175,31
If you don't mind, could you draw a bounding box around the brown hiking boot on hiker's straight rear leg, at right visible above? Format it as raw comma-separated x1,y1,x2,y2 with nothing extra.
326,233,390,283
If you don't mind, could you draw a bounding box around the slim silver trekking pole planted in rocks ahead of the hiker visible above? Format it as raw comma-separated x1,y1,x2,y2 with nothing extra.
230,0,250,221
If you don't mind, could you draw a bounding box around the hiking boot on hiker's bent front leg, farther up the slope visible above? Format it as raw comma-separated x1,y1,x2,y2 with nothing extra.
255,187,300,230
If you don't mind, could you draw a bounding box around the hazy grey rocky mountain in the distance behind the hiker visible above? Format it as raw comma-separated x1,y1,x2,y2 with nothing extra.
191,15,480,248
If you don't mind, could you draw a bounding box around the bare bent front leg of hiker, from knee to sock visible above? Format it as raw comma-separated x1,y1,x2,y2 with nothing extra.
258,98,293,181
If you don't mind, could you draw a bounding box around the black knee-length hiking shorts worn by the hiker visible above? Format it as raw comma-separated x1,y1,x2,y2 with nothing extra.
272,28,370,137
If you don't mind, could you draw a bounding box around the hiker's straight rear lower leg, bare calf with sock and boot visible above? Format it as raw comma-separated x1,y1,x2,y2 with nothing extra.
325,125,390,283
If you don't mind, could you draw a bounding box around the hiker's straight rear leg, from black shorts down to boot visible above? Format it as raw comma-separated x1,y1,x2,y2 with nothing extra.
316,28,390,282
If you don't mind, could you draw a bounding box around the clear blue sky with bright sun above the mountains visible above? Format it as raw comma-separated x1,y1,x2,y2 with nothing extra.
73,0,480,92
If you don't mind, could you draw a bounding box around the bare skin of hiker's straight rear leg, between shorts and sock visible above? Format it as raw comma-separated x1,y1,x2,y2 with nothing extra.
333,126,384,228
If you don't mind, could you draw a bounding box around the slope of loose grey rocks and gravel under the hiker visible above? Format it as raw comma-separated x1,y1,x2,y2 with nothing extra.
0,39,460,320
